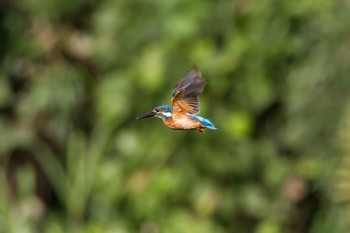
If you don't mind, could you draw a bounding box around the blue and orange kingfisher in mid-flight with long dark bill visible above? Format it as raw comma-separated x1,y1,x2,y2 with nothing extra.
137,66,217,133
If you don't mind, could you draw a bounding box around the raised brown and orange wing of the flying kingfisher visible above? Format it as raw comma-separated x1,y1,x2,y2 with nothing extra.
171,66,206,116
